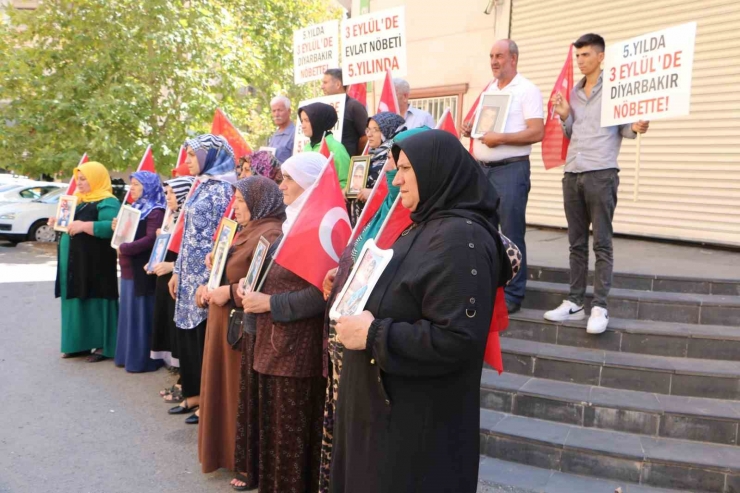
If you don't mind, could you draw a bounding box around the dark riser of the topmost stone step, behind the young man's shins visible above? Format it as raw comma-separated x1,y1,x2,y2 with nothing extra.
527,265,740,296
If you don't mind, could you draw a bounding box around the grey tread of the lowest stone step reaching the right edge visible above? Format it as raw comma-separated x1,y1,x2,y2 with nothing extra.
480,409,740,475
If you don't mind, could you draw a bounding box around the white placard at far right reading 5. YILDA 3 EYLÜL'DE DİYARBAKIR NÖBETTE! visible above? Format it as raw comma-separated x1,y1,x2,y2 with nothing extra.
601,22,696,127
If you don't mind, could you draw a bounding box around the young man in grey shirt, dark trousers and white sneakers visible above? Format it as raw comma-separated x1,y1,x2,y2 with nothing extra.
545,34,648,334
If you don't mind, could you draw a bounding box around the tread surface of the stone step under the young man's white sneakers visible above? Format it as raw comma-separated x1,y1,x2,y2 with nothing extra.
502,308,740,341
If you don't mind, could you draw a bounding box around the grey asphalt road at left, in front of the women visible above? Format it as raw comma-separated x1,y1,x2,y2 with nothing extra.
0,242,525,493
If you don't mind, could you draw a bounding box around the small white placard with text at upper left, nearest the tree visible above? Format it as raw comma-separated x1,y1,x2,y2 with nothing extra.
293,21,339,84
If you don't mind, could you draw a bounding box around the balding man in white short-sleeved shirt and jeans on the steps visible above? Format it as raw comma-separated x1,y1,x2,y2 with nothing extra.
462,39,545,313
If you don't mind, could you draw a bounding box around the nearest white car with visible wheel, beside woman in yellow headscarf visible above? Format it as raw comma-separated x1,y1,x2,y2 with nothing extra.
0,187,62,243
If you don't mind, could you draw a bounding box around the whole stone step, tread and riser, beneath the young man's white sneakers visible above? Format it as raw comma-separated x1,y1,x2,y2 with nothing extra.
501,308,740,361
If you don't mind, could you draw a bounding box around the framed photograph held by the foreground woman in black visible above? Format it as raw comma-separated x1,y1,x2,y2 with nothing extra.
329,240,393,321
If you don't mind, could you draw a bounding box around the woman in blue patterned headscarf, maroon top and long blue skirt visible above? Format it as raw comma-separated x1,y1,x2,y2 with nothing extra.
112,171,166,373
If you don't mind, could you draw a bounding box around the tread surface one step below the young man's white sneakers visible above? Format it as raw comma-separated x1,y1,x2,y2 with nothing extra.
501,337,740,378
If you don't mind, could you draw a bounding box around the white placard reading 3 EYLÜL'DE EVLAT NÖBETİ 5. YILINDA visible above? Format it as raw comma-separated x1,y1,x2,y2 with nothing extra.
342,7,408,85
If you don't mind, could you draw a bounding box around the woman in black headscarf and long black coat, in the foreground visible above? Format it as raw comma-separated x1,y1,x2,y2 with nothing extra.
330,130,511,493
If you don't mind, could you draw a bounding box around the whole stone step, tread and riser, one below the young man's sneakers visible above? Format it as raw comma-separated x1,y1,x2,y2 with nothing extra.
501,338,740,400
